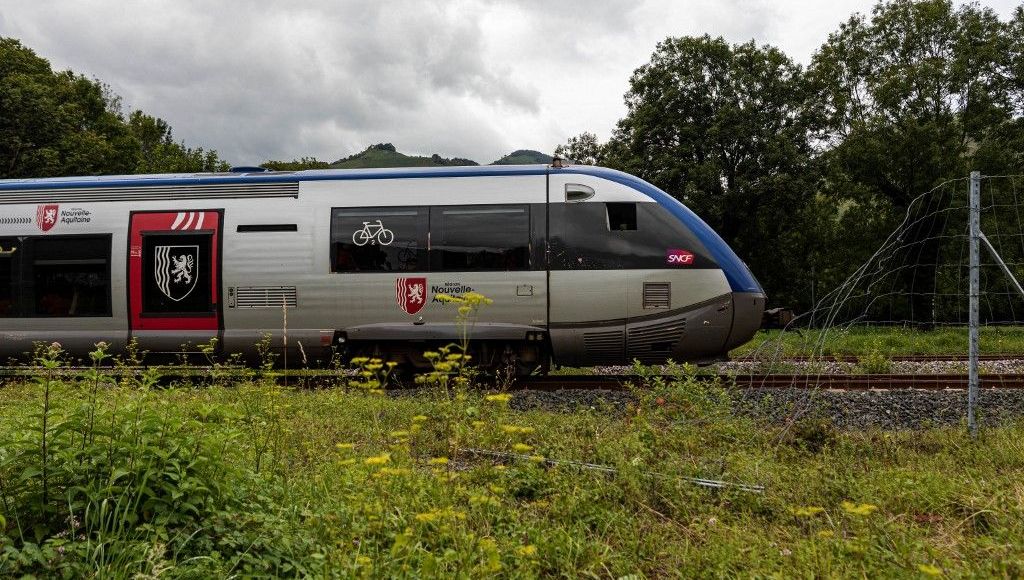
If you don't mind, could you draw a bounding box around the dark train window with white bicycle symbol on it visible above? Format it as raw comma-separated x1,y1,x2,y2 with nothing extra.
331,207,429,272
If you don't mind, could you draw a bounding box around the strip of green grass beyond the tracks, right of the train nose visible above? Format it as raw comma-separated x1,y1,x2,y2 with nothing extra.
730,326,1024,358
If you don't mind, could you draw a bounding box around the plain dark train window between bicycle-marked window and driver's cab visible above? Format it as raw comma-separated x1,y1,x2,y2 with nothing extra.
430,205,529,272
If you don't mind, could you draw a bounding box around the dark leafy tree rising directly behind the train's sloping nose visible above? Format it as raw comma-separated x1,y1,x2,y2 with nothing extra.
602,36,828,305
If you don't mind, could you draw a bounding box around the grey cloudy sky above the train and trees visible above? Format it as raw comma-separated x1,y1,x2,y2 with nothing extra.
0,0,1019,165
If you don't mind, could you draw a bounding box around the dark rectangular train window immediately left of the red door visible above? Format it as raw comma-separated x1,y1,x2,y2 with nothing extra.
30,236,111,317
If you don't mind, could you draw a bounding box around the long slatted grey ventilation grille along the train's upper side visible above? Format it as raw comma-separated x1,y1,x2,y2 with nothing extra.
0,181,299,208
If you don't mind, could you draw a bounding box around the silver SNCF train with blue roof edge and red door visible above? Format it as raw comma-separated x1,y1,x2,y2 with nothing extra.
0,165,765,372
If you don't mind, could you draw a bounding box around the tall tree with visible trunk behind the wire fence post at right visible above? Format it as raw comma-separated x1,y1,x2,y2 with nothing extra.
809,0,1020,327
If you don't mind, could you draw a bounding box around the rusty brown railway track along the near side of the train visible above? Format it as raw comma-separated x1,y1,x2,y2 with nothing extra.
0,367,1024,390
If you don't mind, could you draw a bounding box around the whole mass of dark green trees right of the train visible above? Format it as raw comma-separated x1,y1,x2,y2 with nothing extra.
556,0,1024,315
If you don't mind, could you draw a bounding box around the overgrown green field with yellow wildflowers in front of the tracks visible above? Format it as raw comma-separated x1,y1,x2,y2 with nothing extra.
0,358,1024,578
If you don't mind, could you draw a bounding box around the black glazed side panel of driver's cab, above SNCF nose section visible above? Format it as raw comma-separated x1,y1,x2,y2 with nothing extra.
550,203,714,270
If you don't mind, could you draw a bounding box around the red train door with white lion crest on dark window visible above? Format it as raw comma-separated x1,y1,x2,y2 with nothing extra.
127,209,223,353
